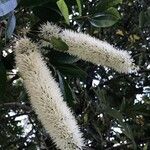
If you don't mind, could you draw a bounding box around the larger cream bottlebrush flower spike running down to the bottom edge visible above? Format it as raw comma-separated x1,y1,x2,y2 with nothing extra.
15,38,84,150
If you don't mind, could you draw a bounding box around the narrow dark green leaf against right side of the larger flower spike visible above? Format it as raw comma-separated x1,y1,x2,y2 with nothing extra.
57,71,75,107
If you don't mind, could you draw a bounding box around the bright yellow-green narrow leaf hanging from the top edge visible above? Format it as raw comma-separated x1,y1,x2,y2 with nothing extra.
57,0,69,24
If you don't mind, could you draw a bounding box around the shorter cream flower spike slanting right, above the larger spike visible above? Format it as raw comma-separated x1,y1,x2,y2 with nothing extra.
39,22,136,73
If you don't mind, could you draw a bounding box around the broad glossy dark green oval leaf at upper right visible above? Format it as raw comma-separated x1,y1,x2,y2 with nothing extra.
89,7,120,27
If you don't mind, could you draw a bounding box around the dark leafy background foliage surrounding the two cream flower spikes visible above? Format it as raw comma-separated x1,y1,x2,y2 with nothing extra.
0,0,150,150
